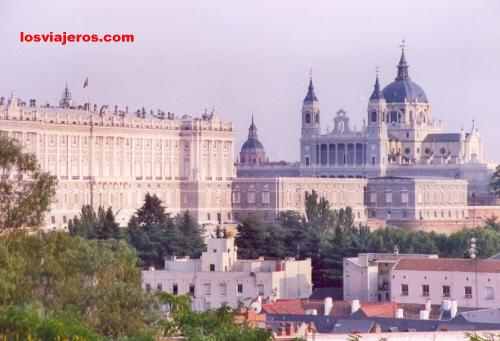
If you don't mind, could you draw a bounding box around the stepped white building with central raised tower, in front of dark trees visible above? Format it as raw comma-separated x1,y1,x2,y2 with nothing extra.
142,238,312,311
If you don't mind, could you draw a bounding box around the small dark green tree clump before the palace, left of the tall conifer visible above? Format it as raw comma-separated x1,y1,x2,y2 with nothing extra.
68,205,120,239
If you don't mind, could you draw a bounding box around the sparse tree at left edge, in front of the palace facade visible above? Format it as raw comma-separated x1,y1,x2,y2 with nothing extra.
0,135,56,229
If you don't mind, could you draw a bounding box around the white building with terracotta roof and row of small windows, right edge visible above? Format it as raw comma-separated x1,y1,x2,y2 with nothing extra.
391,258,500,308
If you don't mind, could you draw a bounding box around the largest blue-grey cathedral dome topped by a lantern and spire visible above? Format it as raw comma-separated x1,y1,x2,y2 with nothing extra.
382,49,428,103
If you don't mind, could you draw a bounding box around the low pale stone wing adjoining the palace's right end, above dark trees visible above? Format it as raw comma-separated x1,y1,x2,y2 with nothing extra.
232,177,367,222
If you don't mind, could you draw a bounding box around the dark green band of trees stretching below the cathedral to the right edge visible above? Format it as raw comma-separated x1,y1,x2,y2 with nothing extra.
236,191,500,286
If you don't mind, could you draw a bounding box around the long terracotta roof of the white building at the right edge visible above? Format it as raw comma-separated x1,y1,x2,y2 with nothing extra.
393,258,500,273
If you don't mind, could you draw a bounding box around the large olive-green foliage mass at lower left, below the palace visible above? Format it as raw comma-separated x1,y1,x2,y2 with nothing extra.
0,232,151,336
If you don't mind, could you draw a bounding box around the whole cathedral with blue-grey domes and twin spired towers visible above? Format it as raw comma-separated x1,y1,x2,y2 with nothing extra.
238,47,494,204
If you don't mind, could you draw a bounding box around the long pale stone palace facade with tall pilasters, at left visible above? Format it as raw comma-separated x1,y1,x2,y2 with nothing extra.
0,92,235,228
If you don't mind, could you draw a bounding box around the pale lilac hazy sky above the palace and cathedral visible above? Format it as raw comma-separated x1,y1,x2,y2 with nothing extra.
0,0,500,161
